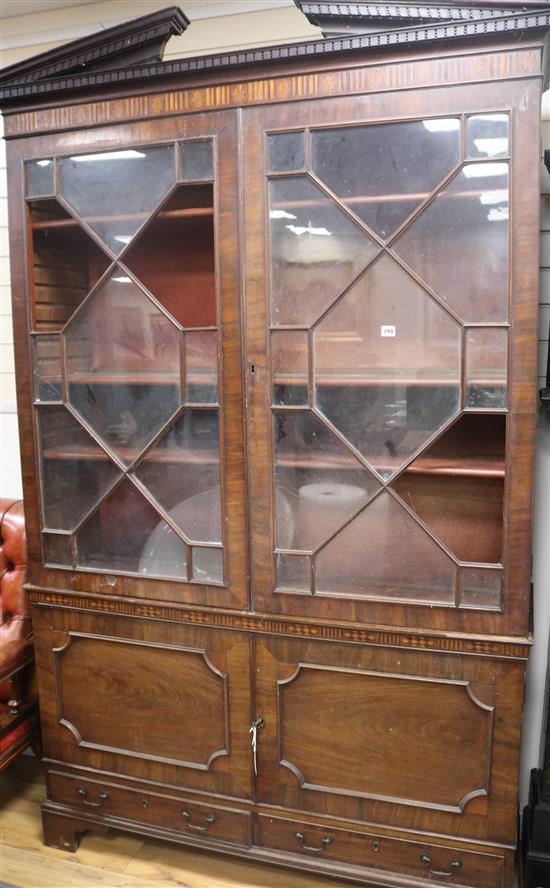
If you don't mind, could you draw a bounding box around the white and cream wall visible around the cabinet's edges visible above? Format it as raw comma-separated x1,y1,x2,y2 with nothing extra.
0,0,550,804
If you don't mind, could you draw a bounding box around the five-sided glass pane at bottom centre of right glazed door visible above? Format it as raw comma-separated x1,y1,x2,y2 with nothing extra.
316,491,456,604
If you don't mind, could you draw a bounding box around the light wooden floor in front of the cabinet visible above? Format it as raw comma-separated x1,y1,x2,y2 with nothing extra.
0,755,350,888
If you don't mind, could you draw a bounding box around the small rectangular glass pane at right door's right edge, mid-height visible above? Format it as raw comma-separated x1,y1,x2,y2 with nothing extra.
466,327,508,410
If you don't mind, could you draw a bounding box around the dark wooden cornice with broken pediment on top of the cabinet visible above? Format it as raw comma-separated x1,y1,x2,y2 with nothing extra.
0,0,550,112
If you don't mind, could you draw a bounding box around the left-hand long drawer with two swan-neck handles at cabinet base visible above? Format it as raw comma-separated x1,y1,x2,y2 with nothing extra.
48,771,250,845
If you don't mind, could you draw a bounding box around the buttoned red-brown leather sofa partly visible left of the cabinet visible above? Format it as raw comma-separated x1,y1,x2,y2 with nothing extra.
0,499,38,770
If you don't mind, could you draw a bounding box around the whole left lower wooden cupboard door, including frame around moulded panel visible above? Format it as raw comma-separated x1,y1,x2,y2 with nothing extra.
33,605,252,798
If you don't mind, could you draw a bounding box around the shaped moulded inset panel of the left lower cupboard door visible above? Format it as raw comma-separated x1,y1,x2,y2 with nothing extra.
53,632,229,771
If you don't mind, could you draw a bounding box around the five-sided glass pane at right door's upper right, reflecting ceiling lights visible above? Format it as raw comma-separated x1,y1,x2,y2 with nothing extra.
395,163,509,323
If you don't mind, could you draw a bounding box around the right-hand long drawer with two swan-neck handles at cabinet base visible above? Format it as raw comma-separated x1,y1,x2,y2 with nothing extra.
258,815,504,888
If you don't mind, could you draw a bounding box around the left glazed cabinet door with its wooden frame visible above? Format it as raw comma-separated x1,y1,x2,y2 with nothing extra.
20,112,247,607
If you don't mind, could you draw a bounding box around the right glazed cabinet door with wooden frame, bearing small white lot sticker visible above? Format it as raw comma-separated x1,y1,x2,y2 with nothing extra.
245,76,536,633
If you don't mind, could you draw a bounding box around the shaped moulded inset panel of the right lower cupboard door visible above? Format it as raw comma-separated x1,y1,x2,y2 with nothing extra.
277,663,494,811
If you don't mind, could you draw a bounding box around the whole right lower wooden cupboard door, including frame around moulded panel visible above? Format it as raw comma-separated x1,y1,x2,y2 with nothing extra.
255,636,524,843
